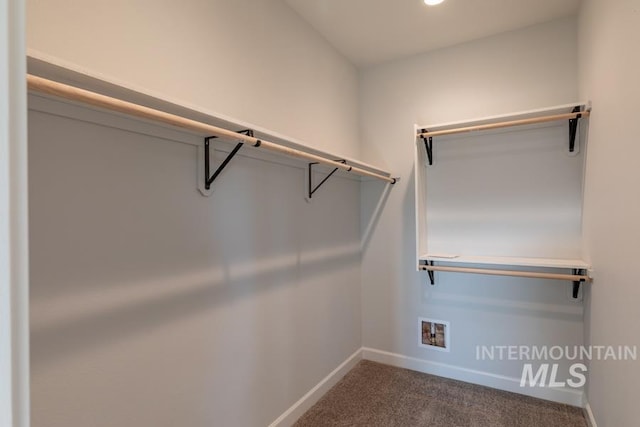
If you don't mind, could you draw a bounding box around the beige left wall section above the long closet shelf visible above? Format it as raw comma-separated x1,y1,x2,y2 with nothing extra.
27,0,358,157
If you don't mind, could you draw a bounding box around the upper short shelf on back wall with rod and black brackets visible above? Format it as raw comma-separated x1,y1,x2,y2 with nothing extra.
417,103,591,165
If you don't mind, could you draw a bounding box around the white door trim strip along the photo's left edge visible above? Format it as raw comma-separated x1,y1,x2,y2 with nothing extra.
0,0,29,427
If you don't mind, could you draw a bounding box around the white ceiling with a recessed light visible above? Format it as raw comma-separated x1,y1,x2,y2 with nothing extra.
284,0,580,66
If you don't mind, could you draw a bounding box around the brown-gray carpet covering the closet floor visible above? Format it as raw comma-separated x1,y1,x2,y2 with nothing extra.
294,360,587,427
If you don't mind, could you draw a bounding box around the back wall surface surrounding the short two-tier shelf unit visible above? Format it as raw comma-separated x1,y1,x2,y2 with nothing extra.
360,19,583,404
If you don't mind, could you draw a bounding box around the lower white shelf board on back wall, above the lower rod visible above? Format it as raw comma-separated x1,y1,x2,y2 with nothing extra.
420,253,591,270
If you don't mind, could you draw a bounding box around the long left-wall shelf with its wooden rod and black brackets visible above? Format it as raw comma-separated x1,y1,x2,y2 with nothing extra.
27,56,398,200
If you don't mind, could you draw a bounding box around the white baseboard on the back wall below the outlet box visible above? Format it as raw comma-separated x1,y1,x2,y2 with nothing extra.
362,347,584,407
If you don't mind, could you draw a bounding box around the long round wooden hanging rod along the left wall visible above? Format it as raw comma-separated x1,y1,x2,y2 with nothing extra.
27,74,396,184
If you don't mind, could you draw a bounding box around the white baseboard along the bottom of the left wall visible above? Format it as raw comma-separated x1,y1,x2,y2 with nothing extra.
269,349,362,427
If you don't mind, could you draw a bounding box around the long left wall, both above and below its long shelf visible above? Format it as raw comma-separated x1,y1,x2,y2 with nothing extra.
28,0,361,427
